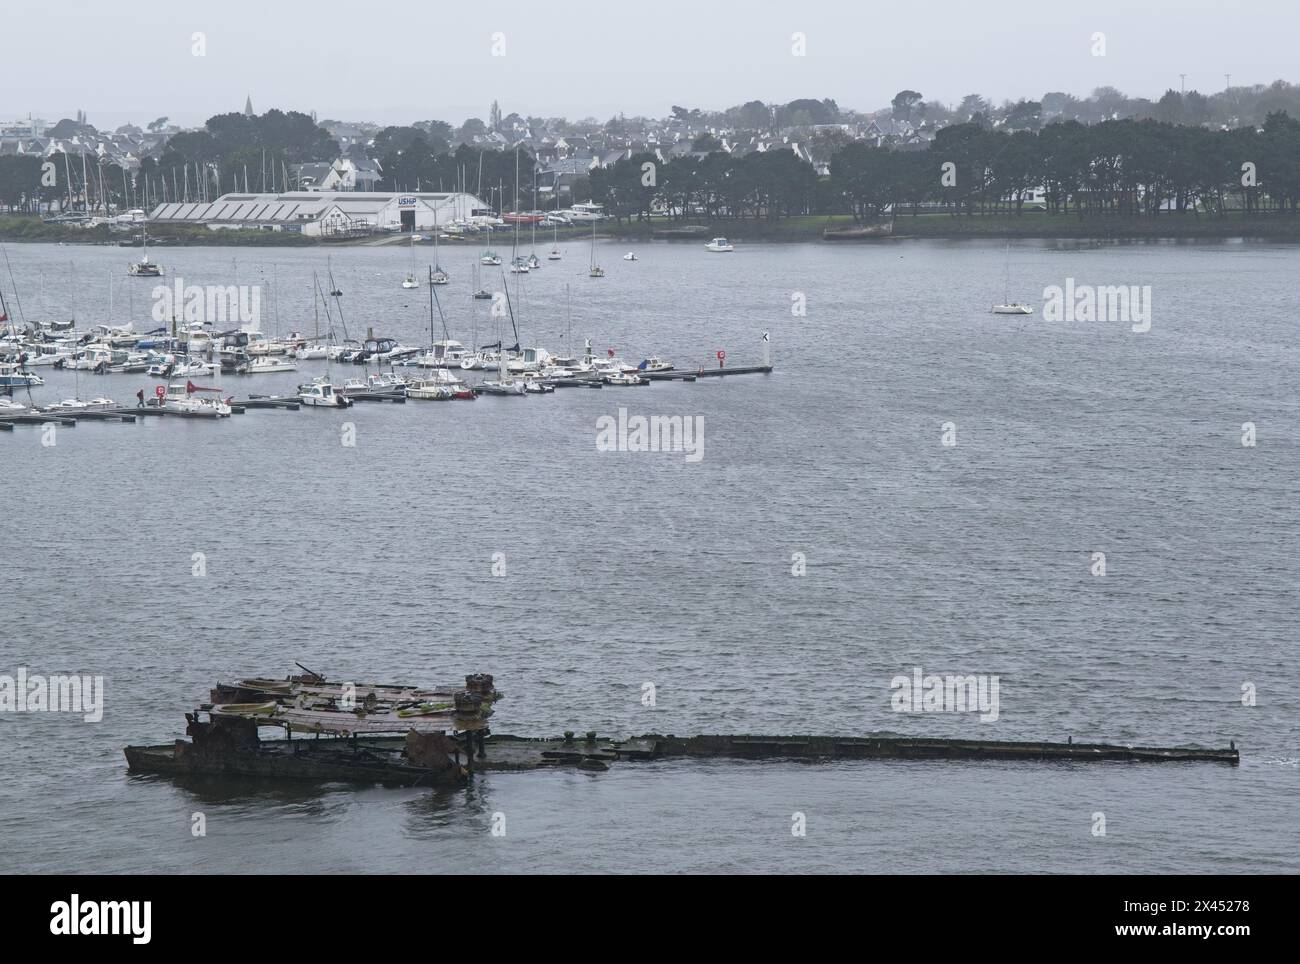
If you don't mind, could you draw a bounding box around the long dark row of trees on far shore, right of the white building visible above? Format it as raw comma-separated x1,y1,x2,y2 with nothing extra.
590,112,1300,221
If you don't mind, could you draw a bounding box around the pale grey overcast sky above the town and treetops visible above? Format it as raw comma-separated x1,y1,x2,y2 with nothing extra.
0,0,1300,127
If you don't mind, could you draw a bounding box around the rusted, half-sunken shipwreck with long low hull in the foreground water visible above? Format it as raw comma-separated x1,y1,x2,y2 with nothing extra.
125,673,1240,786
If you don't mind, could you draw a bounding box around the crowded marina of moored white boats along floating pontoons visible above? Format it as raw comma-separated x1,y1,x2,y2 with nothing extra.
0,236,775,426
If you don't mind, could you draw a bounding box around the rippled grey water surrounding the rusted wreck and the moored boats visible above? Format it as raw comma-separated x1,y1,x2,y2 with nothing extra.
0,242,1300,873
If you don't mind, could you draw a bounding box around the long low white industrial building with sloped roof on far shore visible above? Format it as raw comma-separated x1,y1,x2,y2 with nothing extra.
150,191,493,238
